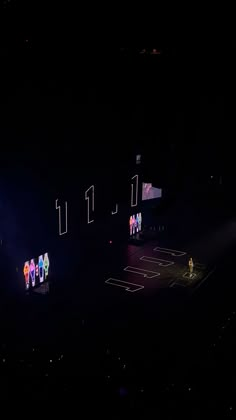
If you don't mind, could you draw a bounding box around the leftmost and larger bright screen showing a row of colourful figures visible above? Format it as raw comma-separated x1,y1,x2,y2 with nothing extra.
23,252,50,290
